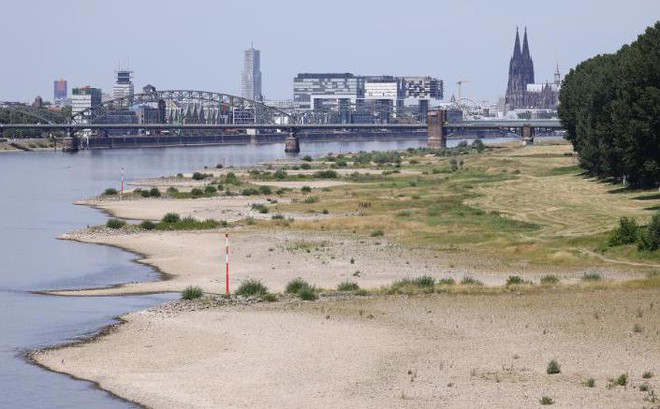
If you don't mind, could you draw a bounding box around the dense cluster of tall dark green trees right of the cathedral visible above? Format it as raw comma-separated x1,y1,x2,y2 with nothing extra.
559,22,660,188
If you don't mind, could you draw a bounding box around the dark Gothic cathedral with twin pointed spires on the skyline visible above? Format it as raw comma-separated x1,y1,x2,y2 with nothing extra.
505,28,561,111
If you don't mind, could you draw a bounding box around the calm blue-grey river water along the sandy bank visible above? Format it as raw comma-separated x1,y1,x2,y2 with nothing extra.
0,139,516,408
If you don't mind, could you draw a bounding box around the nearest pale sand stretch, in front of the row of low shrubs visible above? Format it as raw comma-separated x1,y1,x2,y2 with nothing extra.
35,290,660,408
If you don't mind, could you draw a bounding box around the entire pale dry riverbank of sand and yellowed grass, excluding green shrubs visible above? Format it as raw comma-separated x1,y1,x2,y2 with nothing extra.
34,142,660,408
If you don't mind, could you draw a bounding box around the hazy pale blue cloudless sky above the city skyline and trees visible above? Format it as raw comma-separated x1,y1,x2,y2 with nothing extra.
0,0,660,101
